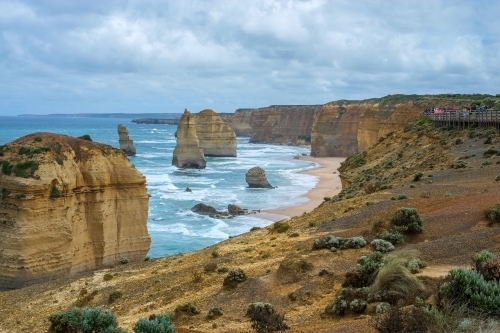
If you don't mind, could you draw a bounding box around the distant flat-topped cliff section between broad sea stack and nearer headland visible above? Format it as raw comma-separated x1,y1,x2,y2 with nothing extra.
250,105,321,144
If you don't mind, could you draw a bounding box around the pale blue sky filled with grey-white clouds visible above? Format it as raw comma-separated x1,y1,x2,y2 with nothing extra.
0,0,500,116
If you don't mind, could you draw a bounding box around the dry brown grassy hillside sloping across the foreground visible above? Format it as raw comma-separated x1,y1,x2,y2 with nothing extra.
0,120,500,332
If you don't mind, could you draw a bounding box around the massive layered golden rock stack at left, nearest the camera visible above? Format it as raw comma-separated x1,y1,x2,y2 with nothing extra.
0,133,151,289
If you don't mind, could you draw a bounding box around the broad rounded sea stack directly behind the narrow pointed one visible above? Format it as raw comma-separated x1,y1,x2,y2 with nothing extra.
196,109,236,157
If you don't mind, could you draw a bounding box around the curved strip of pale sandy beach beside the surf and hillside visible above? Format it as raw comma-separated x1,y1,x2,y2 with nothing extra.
256,156,345,222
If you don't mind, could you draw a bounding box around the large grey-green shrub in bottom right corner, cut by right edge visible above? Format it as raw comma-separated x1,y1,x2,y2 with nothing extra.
440,267,500,316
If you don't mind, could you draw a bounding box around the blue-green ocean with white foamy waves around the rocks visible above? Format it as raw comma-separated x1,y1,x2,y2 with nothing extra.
0,116,318,258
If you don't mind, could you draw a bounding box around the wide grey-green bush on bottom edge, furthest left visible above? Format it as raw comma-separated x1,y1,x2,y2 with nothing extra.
49,307,125,333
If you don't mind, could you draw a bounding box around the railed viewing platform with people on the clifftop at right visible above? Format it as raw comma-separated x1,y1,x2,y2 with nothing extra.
422,109,500,129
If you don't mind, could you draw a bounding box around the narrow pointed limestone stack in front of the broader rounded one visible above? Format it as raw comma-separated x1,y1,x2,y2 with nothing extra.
172,110,207,169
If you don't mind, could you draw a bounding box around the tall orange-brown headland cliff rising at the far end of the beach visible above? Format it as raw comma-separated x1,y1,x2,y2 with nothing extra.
311,95,482,157
